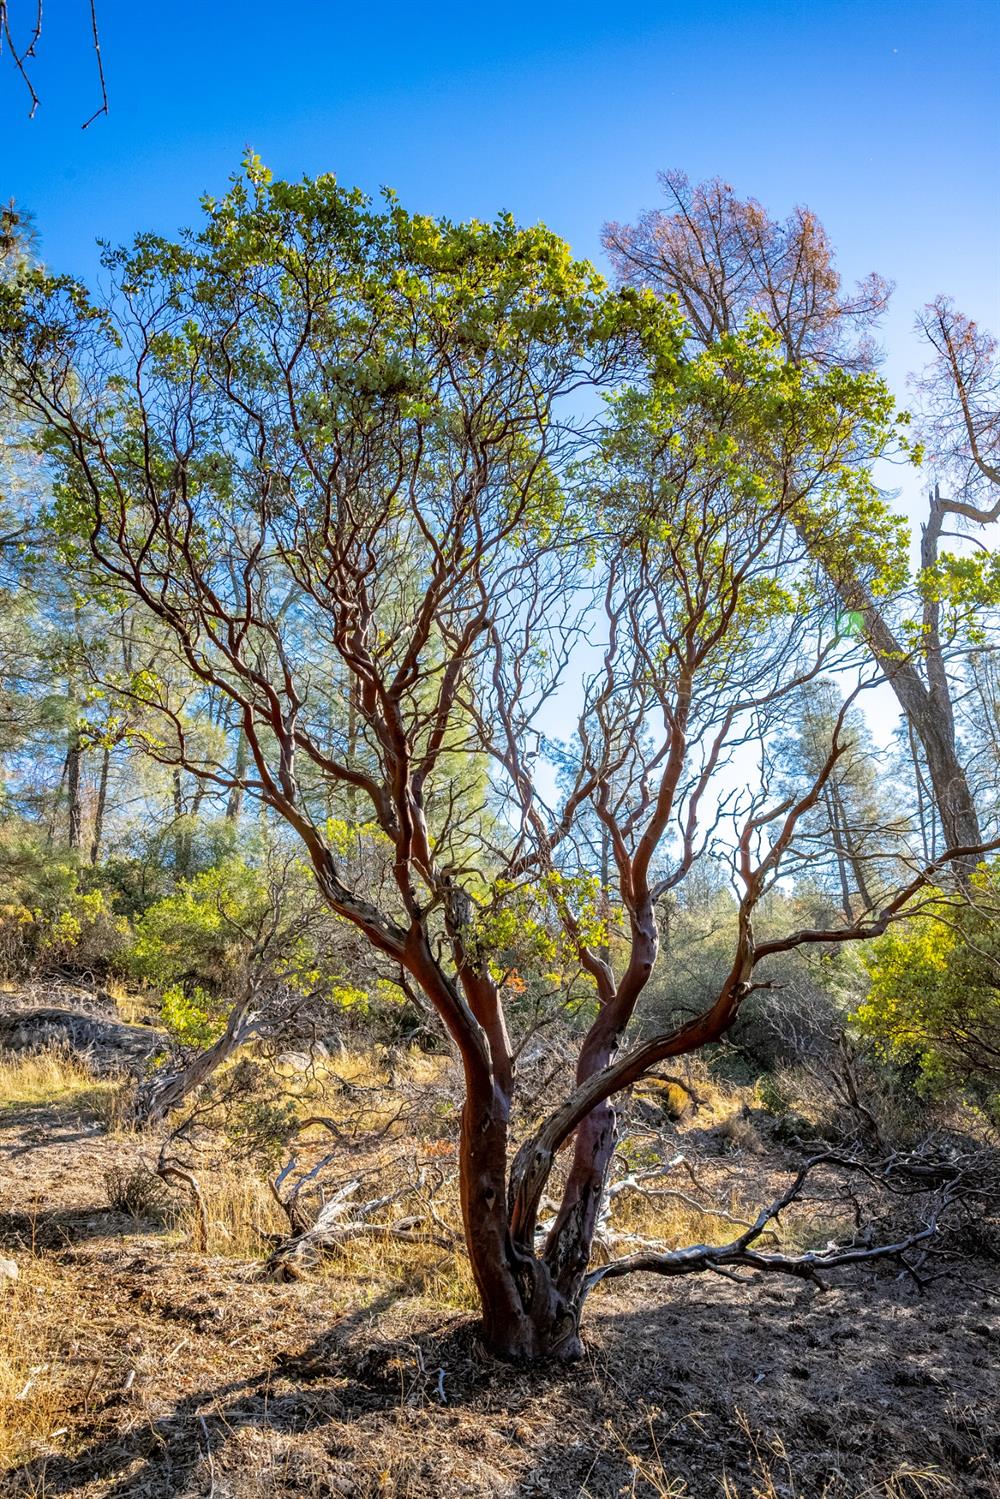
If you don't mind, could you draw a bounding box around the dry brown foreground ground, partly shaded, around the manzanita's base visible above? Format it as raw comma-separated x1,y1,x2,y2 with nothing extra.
0,1037,1000,1499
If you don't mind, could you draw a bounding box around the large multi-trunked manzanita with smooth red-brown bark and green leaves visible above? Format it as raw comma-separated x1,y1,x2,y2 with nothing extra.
0,160,995,1360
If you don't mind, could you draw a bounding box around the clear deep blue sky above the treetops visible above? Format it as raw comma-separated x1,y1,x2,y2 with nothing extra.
0,0,1000,761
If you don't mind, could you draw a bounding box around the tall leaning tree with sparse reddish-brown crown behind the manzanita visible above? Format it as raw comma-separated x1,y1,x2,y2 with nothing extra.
604,172,988,869
